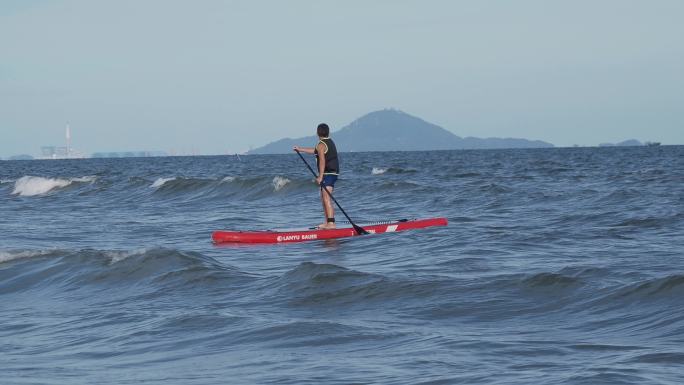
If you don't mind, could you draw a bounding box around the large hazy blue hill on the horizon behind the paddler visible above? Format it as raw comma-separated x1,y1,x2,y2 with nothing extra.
249,109,553,154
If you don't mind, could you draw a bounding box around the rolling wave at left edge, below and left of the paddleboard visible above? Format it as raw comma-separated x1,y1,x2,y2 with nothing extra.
0,248,249,293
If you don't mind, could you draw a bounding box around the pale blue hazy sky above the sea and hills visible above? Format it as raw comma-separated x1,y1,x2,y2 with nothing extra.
0,0,684,157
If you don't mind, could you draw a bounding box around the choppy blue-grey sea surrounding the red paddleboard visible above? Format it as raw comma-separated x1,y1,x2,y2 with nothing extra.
0,146,684,385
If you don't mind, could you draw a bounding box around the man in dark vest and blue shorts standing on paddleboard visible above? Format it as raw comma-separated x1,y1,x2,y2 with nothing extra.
294,123,340,229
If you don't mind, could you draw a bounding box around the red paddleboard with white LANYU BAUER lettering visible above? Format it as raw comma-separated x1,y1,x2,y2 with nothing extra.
211,218,447,243
